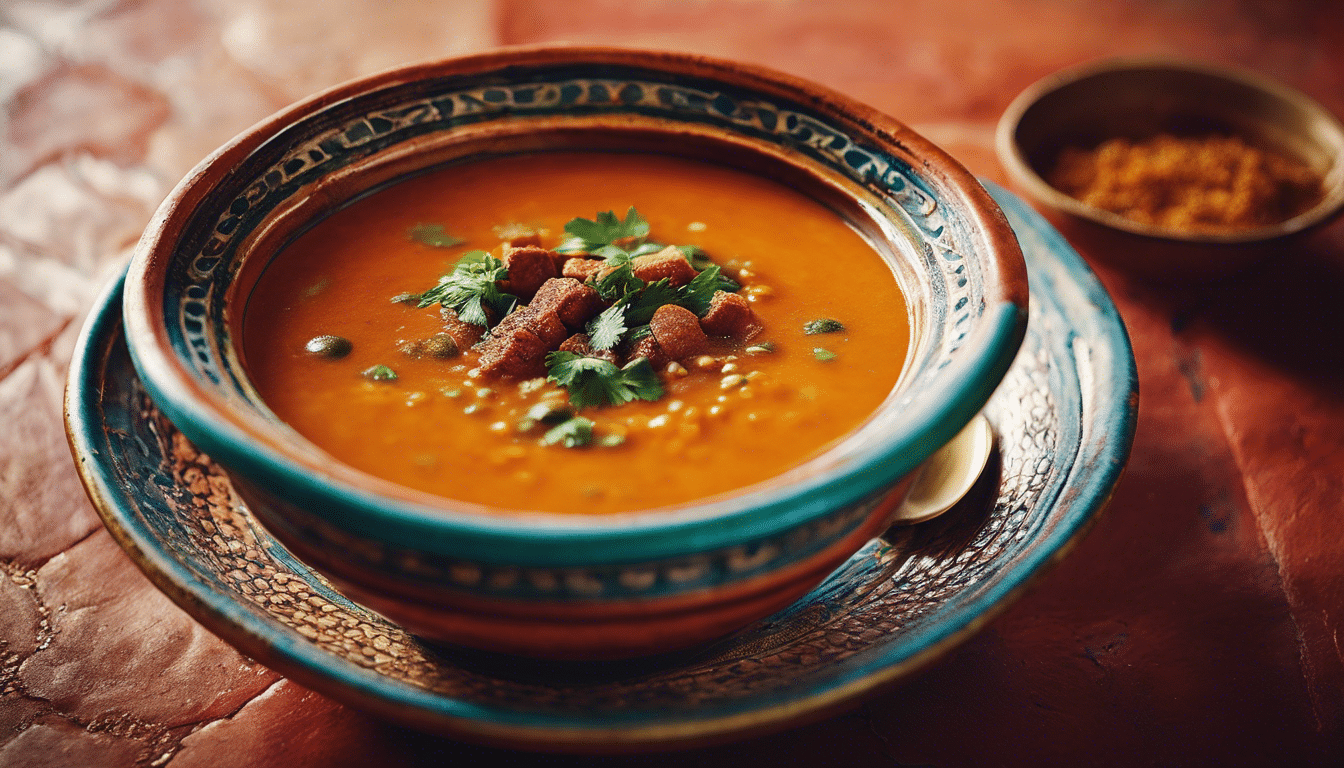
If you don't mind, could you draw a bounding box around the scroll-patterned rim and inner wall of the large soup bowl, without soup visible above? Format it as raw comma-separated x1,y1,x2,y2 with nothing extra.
125,50,1025,562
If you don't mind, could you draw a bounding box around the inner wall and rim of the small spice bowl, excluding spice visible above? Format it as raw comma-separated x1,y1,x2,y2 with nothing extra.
999,61,1344,242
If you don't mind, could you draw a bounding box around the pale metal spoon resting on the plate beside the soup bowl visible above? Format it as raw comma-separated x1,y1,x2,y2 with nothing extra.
892,413,995,525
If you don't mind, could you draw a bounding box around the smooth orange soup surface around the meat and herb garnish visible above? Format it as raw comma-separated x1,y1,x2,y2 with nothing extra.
243,153,909,514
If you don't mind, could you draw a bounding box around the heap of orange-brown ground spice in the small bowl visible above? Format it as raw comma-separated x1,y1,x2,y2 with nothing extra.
1048,135,1321,231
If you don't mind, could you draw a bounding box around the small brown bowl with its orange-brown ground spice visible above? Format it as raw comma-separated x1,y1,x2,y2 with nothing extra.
996,58,1344,281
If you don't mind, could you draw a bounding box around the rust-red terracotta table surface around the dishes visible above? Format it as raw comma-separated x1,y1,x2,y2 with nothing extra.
0,0,1344,768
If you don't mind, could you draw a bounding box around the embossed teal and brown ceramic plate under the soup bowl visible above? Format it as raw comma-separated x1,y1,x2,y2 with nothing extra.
66,188,1137,749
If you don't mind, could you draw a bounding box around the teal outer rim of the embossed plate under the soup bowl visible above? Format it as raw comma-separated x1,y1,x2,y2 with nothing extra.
66,184,1137,751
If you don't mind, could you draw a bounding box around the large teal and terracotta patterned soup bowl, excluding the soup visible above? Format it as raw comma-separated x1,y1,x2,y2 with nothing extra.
124,47,1027,658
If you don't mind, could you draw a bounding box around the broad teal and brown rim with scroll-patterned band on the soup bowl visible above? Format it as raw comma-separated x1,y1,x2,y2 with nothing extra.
125,48,1027,566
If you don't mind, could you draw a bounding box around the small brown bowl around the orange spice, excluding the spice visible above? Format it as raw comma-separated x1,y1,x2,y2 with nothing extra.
996,58,1344,281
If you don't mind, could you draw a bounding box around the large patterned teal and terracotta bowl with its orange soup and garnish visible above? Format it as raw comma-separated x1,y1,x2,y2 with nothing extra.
125,47,1027,658
